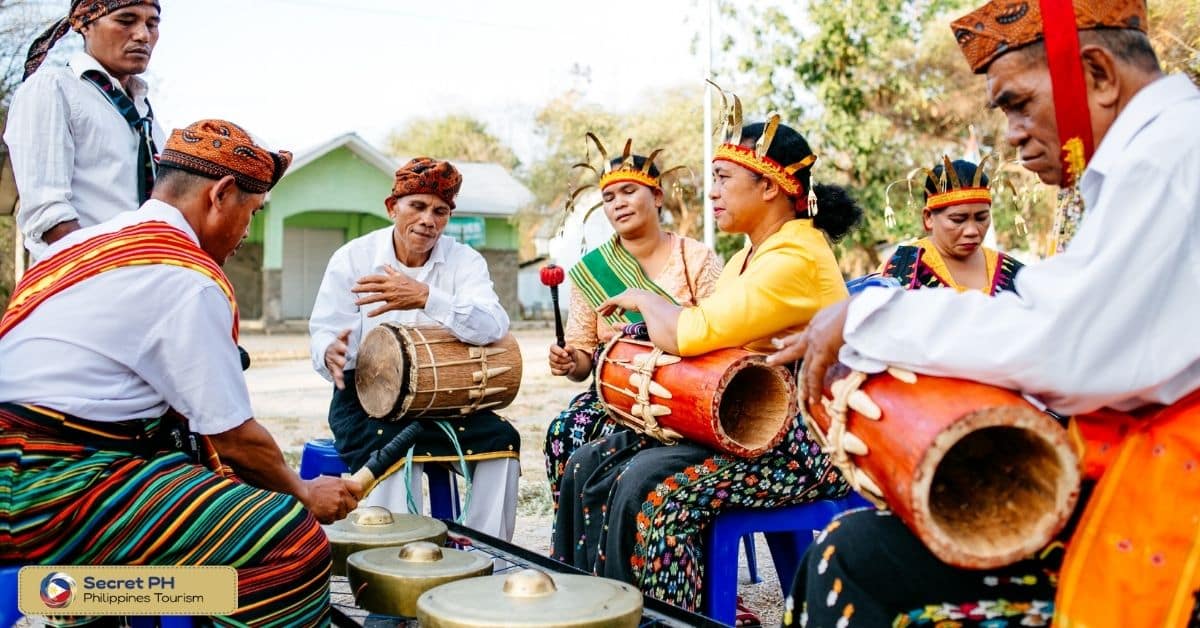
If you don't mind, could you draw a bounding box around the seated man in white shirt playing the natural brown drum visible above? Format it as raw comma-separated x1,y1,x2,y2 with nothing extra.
308,157,521,539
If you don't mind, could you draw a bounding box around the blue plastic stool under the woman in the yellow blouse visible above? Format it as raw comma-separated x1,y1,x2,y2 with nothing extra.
702,495,870,626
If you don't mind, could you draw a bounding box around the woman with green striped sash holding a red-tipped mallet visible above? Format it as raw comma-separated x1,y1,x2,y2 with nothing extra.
545,133,721,510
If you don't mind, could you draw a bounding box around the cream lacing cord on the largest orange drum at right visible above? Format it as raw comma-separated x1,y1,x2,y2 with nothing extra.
800,371,887,508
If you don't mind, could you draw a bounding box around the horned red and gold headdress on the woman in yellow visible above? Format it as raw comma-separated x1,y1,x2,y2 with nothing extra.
708,80,817,216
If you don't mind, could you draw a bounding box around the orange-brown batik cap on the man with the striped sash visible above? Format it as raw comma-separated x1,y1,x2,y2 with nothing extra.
158,120,292,195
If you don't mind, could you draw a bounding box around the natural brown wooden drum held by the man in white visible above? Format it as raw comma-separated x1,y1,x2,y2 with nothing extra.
354,323,521,420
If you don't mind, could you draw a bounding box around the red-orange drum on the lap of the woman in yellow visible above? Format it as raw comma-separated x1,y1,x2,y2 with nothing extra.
596,336,796,457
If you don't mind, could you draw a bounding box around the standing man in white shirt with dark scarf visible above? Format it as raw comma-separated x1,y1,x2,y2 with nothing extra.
5,0,164,261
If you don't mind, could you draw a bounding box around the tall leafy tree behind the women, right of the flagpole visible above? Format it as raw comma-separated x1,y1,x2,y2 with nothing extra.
722,0,1200,275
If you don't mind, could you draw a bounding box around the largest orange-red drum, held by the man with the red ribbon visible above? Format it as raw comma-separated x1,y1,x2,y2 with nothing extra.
804,365,1080,569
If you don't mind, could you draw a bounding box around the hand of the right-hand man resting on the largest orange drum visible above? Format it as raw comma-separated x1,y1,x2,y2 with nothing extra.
767,299,850,405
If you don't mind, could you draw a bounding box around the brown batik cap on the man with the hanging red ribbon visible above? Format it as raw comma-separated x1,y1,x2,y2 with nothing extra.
950,0,1146,74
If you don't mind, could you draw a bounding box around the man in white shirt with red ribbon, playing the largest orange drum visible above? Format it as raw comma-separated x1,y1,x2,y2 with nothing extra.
772,0,1200,628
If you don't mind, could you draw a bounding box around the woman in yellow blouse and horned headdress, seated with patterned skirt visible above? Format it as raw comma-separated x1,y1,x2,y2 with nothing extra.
553,89,862,609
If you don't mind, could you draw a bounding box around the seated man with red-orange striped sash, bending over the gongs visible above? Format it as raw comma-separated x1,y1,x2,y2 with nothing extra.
0,120,360,626
